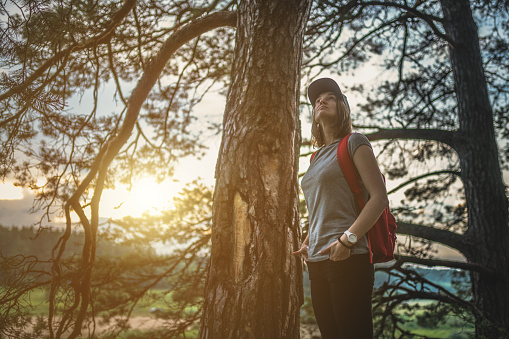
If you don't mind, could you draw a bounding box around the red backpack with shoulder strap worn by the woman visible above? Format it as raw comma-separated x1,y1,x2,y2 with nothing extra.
311,134,397,263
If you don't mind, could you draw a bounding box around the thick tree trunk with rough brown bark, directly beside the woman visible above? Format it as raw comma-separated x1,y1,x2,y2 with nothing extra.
200,0,311,338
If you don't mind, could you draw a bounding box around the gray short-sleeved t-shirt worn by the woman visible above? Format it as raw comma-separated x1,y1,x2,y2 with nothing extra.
301,133,371,262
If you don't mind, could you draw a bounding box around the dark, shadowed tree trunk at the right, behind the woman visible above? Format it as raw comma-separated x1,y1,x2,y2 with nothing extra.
441,0,509,338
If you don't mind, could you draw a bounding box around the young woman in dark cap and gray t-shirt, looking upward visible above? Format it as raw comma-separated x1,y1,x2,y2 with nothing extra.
293,78,388,339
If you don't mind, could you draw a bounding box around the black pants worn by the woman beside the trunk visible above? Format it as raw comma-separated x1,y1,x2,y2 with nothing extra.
308,254,375,339
